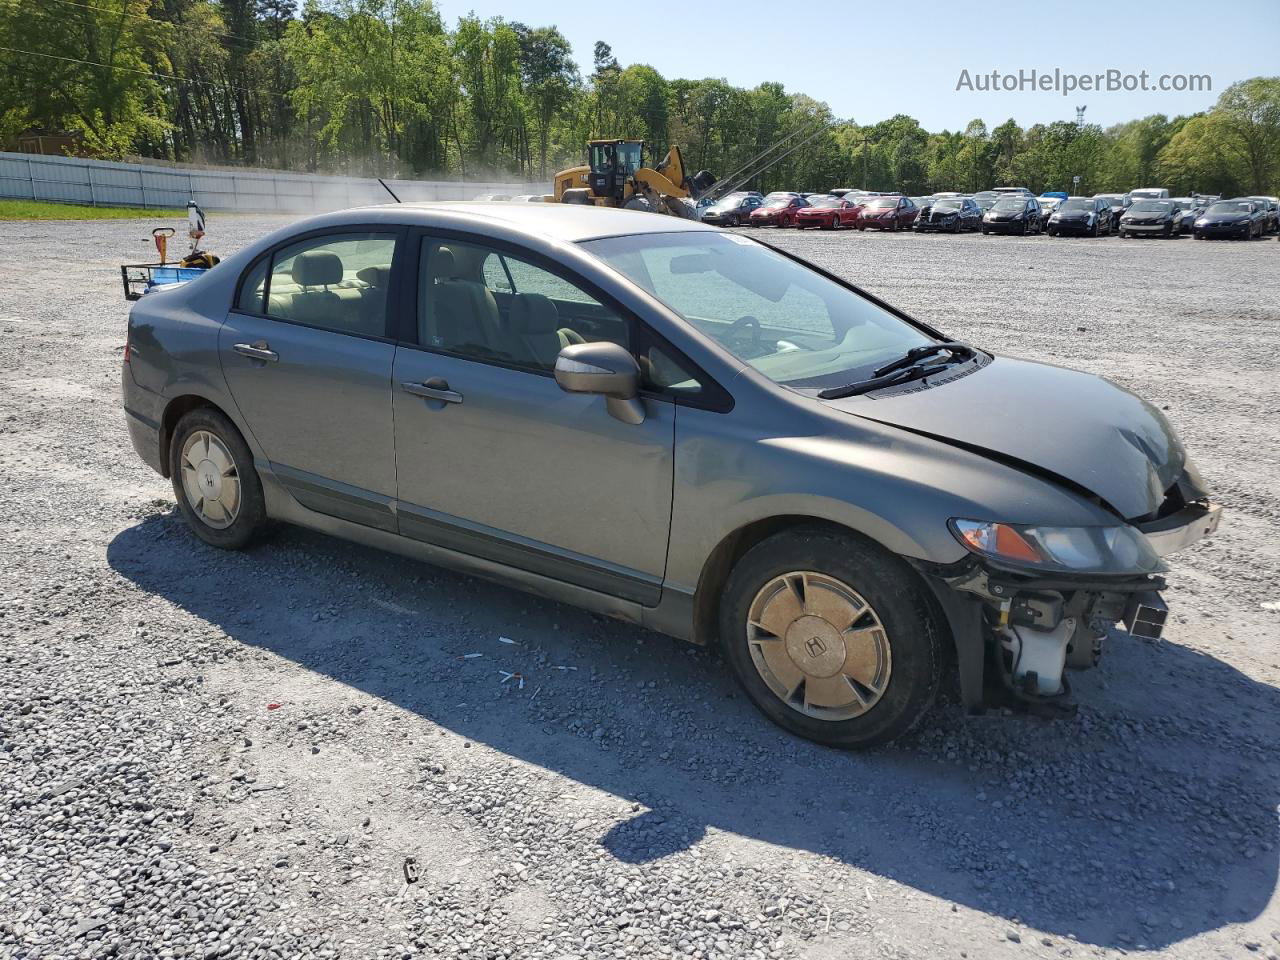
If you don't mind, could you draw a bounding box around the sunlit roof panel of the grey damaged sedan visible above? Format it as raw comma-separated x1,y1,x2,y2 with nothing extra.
340,200,716,243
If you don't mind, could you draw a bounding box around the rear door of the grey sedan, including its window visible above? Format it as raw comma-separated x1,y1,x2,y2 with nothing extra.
218,227,403,530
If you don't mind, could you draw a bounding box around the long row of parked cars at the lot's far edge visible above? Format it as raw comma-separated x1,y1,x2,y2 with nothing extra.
701,187,1280,239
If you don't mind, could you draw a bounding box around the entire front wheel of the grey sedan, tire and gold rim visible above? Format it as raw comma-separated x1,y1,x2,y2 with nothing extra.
719,527,942,749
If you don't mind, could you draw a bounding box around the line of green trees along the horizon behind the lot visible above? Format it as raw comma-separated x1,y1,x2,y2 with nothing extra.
0,0,1280,195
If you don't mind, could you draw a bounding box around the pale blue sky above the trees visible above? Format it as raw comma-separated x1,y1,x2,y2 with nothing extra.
436,0,1280,131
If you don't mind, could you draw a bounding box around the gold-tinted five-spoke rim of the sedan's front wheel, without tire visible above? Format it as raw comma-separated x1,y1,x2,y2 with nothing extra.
746,571,892,721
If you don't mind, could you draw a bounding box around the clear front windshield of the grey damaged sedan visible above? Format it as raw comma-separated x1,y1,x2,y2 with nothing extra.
582,230,933,389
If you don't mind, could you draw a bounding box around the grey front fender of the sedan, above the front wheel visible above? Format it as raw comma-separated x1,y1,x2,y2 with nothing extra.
666,407,1114,591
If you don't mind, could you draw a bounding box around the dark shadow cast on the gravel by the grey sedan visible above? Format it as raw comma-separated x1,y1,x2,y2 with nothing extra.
108,513,1280,948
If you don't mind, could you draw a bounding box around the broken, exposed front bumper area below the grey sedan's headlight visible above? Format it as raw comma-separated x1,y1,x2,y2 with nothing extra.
919,500,1221,714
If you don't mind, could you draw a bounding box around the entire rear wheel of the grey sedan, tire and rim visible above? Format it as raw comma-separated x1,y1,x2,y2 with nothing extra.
169,407,266,550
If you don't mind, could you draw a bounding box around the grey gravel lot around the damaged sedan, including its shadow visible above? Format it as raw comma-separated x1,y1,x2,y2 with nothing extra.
0,216,1280,960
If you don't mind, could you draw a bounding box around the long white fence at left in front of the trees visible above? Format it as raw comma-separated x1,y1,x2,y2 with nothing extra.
0,152,548,214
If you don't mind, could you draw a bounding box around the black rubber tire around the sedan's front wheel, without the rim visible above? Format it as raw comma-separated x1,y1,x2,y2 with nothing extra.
719,527,943,749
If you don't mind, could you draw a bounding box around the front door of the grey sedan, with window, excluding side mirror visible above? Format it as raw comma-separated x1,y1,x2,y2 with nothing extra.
393,234,675,605
